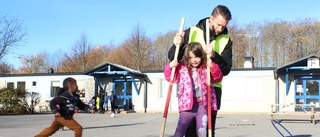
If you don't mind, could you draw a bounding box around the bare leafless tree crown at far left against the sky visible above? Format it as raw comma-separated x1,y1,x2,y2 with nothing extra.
0,15,27,59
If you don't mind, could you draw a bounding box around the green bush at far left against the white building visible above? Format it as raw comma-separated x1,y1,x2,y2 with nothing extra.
0,88,40,114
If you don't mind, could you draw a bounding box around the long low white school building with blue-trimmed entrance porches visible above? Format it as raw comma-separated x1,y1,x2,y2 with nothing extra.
0,55,320,113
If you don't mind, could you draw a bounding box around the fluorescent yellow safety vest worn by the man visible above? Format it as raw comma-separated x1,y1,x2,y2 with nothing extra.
189,27,229,88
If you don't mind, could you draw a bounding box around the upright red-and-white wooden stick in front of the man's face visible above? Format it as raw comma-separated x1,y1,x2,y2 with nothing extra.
206,19,212,137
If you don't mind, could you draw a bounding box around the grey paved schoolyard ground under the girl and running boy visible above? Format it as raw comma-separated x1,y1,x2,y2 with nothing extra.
0,113,320,137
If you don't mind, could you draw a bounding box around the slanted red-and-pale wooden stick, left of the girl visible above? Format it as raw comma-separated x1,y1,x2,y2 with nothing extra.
160,18,185,137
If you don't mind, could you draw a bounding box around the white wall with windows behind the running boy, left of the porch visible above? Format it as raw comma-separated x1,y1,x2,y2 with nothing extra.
0,73,95,108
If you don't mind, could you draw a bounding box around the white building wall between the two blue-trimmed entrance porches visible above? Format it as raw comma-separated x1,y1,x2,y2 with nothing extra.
133,68,275,113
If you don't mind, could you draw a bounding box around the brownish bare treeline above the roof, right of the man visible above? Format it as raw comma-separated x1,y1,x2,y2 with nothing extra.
228,18,320,67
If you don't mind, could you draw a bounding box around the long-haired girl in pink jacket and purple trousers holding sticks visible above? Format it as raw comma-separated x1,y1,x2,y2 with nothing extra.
164,42,223,137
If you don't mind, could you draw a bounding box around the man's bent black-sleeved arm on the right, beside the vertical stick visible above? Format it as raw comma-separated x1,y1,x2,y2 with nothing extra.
211,39,232,76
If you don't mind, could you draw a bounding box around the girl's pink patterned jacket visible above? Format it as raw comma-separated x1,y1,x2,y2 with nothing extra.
164,63,223,112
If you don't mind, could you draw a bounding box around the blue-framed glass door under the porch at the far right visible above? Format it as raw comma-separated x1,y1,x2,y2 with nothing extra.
295,77,320,111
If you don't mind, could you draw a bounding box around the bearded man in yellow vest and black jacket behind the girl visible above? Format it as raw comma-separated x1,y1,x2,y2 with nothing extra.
168,5,232,137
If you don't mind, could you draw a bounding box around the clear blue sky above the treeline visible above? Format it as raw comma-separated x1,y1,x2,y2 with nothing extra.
0,0,320,68
